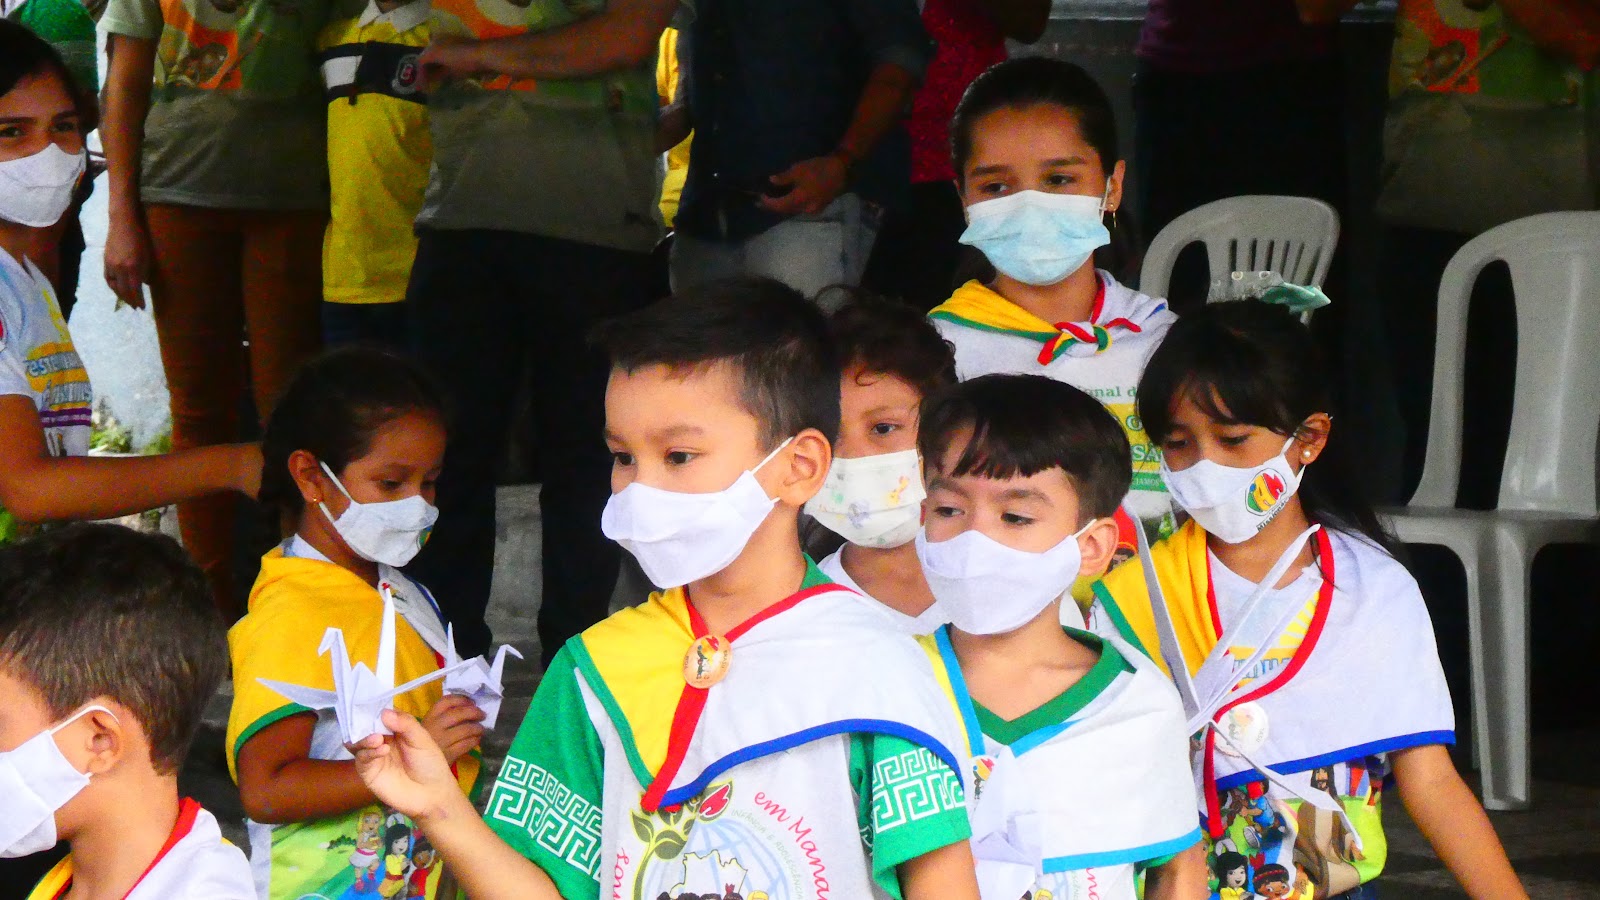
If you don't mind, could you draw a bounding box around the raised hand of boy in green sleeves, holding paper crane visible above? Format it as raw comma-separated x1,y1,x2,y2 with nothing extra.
349,706,464,822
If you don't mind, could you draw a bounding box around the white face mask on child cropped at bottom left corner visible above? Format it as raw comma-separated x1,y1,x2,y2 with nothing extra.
0,706,117,858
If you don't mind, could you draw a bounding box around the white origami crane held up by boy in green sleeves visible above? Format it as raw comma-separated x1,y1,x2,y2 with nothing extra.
256,585,476,743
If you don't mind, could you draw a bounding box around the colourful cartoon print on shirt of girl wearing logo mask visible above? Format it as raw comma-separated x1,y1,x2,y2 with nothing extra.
1206,756,1387,900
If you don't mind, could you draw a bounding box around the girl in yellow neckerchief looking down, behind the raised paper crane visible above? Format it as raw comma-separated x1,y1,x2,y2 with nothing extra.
227,348,483,898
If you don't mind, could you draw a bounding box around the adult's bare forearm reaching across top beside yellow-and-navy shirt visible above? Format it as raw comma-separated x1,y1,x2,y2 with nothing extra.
421,0,678,83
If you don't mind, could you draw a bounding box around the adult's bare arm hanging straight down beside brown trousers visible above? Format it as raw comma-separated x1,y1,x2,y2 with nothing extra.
101,34,155,307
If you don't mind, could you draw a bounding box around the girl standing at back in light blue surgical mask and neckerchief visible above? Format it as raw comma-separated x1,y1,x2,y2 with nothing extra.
930,58,1176,564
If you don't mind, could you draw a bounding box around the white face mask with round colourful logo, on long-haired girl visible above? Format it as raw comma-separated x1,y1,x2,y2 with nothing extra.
1162,437,1306,544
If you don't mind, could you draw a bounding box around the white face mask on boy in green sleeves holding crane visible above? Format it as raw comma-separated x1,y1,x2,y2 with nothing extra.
600,437,794,588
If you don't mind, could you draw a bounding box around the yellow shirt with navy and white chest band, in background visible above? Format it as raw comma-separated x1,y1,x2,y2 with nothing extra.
317,0,434,303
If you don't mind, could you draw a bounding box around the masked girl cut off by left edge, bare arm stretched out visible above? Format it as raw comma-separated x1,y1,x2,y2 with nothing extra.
0,21,261,570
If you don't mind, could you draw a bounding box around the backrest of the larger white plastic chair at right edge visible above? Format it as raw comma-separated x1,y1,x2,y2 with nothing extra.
1411,213,1600,517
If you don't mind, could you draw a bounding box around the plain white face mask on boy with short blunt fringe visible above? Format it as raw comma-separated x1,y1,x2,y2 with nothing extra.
917,519,1096,634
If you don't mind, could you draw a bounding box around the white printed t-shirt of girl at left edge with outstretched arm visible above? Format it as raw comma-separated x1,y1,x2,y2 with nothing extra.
0,250,93,456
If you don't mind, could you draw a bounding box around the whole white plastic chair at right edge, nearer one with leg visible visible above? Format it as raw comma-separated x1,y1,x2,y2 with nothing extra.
1386,213,1600,809
